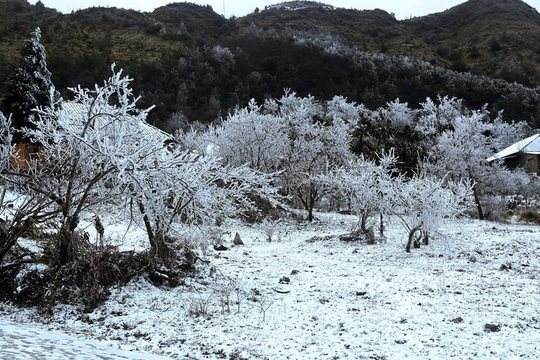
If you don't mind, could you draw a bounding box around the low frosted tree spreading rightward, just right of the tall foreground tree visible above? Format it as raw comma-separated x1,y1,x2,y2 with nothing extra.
119,147,276,261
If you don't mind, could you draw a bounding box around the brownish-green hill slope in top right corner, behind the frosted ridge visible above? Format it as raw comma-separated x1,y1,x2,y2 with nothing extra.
403,0,540,86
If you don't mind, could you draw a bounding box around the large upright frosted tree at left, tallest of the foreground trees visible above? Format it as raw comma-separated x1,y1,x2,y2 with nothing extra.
24,66,155,265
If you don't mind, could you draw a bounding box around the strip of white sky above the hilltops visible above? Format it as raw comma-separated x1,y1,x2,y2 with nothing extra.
30,0,540,20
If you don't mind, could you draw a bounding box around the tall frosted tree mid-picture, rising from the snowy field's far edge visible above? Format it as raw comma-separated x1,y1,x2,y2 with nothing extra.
264,92,356,221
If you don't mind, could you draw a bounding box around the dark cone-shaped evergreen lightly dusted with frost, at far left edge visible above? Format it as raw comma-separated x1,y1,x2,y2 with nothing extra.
2,27,57,139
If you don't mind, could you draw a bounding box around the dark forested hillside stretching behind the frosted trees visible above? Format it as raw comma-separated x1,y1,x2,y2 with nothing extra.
0,0,540,129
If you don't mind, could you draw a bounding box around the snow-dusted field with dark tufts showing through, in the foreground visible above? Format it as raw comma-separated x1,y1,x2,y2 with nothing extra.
0,214,540,359
